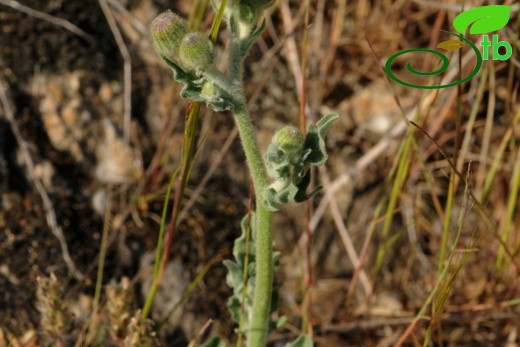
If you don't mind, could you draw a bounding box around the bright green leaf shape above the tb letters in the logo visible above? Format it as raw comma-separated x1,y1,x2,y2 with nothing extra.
453,5,513,34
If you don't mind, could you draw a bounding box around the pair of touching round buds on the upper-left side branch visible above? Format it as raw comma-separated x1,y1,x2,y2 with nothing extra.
150,11,215,71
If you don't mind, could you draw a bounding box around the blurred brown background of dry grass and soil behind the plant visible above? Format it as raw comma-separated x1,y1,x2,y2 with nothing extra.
0,0,520,347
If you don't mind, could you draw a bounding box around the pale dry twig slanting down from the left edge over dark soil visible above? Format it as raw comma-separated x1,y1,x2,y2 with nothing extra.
0,80,83,279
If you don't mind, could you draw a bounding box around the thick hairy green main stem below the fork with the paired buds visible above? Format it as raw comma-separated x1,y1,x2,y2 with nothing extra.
233,101,273,347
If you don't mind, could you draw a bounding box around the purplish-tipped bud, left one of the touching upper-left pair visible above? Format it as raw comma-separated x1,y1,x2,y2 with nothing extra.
150,11,188,59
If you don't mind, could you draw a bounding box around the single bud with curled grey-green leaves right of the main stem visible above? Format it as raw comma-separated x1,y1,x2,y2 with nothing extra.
264,113,339,211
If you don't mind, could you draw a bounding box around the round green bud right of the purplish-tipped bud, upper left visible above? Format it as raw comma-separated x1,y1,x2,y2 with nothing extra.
179,32,215,70
